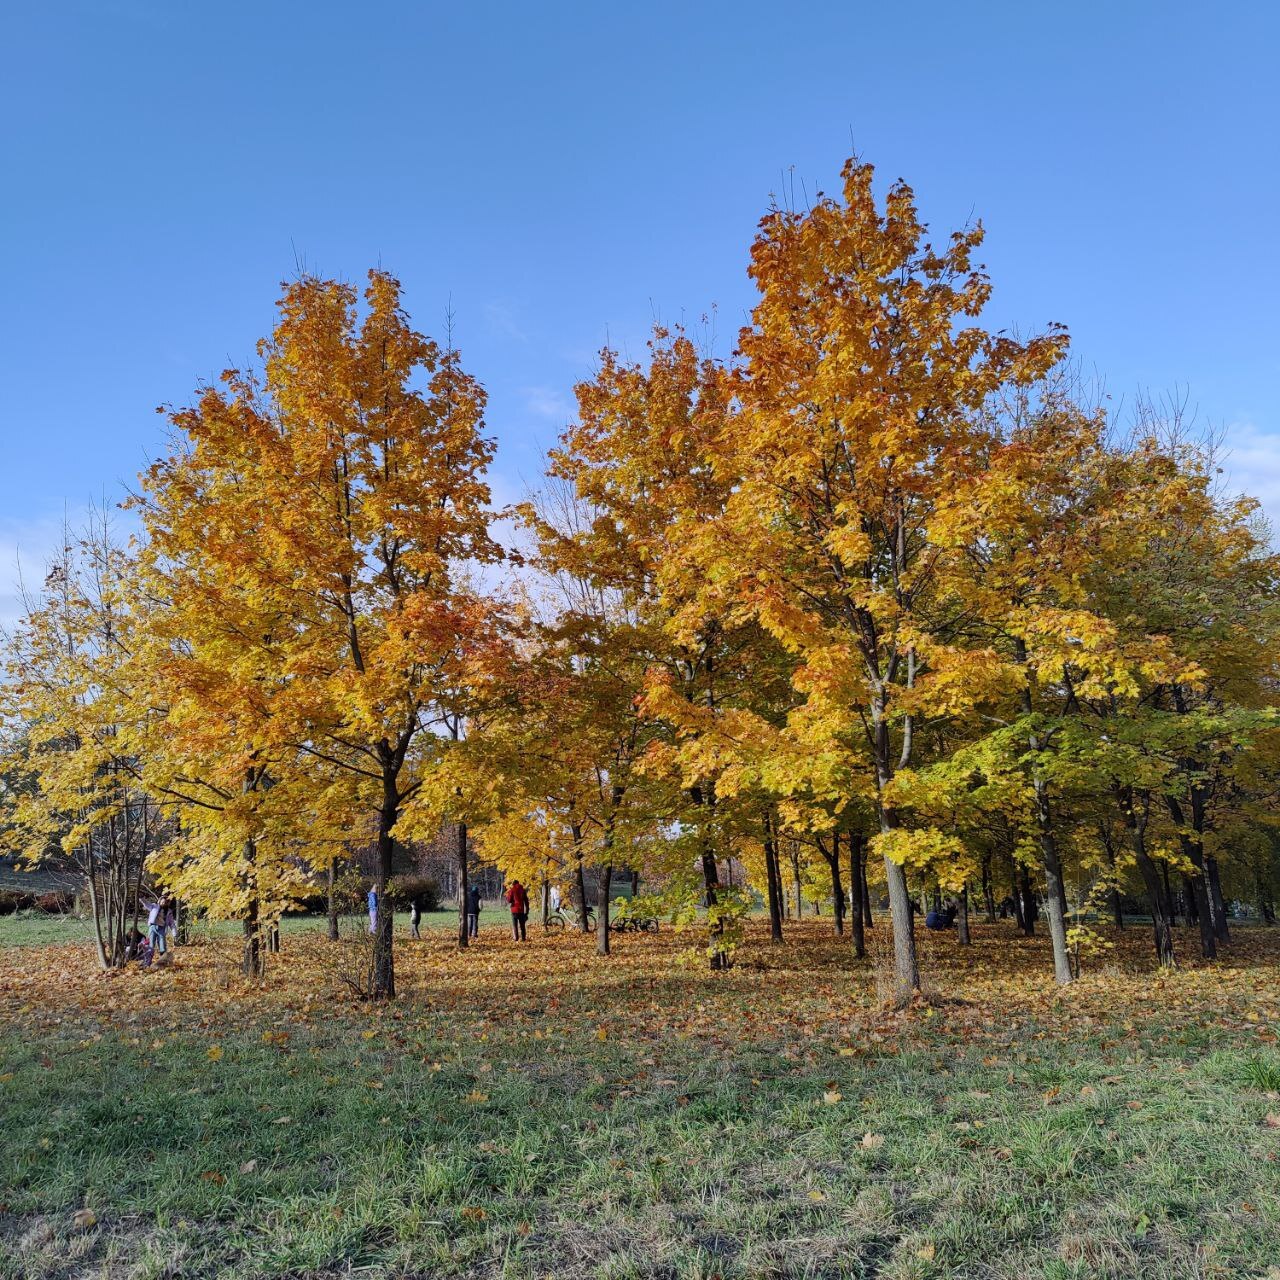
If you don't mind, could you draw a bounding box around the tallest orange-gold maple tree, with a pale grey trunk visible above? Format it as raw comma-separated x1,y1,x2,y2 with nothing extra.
704,160,1065,998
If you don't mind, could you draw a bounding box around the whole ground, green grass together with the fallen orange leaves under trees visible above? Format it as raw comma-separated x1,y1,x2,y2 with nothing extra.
0,915,1280,1280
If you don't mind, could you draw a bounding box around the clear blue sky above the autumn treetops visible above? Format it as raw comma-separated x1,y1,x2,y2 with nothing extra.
0,0,1280,614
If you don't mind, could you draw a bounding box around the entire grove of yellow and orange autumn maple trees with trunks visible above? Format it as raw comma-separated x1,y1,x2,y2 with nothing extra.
0,160,1280,998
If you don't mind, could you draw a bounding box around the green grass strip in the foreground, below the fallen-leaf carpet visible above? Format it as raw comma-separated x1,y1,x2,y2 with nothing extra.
0,1021,1280,1280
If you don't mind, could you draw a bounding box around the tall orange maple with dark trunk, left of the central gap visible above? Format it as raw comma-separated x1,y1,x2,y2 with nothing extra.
152,271,499,996
